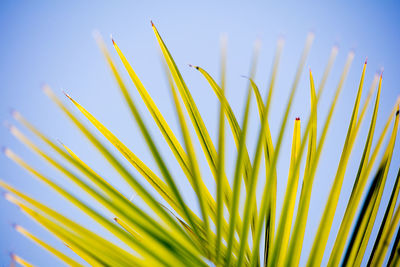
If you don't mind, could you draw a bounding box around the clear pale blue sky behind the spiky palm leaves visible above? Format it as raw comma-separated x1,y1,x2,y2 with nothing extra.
0,0,400,266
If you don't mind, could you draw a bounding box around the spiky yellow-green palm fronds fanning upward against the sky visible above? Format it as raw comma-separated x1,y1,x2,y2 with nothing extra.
0,23,400,266
